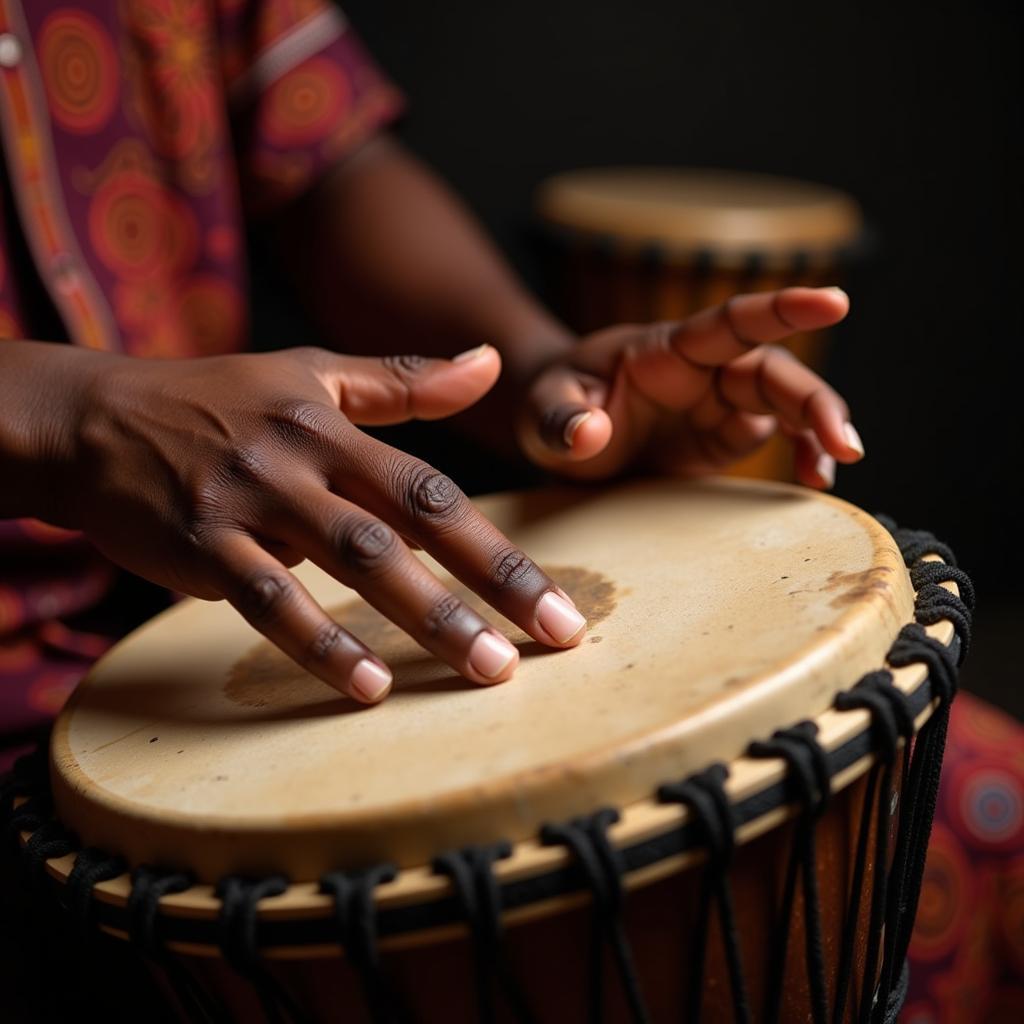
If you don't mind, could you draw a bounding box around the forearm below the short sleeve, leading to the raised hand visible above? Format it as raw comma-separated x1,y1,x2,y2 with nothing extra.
272,138,571,395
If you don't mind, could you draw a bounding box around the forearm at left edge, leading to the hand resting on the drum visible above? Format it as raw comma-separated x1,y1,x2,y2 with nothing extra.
0,341,102,523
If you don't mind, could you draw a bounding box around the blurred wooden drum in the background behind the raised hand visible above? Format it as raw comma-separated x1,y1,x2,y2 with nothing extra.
537,167,866,479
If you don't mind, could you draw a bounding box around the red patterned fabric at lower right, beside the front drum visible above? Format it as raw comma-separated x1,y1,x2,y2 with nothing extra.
900,693,1024,1024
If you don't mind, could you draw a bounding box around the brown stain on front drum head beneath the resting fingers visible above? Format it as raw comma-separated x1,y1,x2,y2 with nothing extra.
224,565,623,709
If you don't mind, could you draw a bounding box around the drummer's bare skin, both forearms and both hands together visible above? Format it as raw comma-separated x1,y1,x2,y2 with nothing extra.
0,139,863,702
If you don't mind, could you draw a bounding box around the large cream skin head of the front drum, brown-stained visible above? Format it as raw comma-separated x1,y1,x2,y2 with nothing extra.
52,481,912,881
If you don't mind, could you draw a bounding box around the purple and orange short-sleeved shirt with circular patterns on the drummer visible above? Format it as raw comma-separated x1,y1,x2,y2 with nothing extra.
0,0,401,745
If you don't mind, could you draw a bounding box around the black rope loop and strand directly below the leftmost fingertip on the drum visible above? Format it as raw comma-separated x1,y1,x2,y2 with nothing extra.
319,864,409,1024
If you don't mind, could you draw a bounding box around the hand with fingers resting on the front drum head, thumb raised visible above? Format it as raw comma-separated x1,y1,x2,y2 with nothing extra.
68,346,585,702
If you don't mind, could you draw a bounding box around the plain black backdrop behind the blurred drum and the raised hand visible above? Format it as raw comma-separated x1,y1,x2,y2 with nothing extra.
262,0,1024,714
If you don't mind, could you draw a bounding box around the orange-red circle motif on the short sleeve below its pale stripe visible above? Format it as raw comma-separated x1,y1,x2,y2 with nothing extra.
262,57,351,147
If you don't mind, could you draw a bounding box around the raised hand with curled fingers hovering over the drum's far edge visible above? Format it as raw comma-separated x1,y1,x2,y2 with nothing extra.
519,288,864,488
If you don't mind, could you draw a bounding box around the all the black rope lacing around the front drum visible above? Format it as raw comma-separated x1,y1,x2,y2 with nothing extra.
0,517,974,1024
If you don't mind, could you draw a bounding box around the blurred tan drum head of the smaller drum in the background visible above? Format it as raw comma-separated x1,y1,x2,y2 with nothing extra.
538,167,861,264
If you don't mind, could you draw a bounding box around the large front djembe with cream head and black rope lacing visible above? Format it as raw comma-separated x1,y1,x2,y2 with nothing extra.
5,481,973,1024
